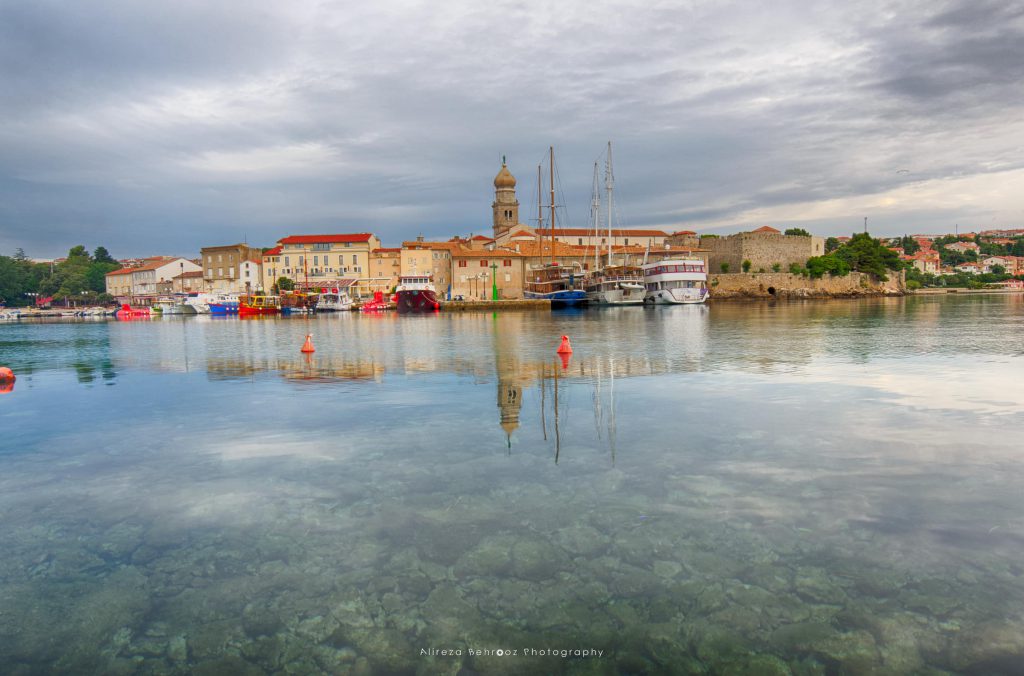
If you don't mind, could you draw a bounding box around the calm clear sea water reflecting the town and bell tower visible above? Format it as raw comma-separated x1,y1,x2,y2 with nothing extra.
0,296,1024,675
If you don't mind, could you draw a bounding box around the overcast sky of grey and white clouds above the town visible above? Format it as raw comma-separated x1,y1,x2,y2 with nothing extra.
0,0,1024,257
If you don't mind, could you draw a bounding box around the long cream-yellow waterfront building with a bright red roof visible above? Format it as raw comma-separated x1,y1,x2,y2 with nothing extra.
263,233,381,296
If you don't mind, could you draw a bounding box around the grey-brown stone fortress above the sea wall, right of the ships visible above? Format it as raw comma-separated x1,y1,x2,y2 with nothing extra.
700,225,825,272
